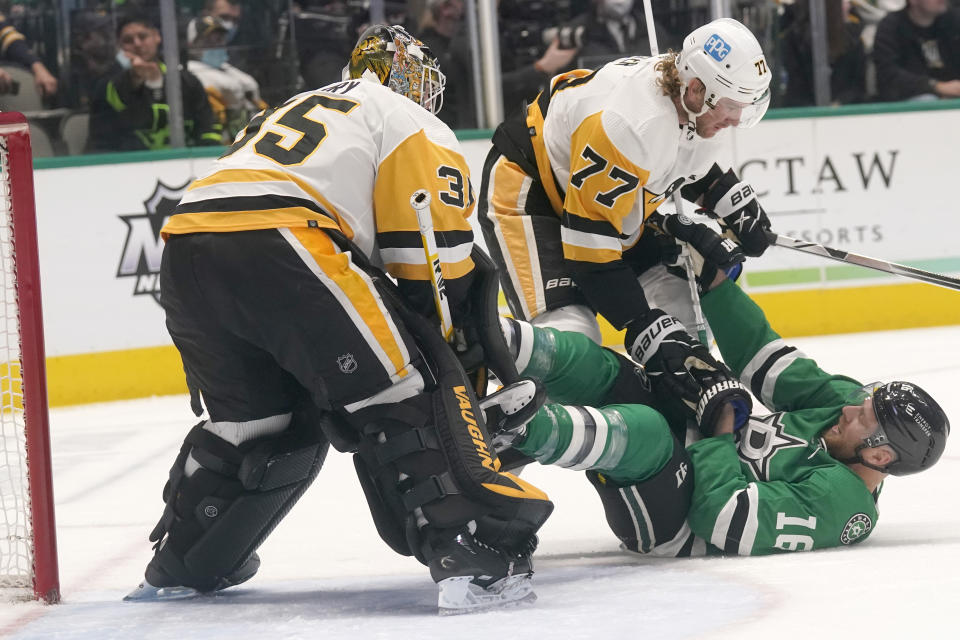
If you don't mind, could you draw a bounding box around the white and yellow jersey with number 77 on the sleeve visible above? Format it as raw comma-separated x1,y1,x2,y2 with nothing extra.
543,57,726,263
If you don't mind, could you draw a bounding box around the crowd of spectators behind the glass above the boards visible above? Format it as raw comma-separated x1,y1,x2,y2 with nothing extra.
0,0,960,156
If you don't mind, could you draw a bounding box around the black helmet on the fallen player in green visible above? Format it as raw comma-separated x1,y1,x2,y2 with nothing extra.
850,382,950,476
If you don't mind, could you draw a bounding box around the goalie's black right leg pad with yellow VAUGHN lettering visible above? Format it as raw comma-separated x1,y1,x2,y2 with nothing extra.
349,306,553,561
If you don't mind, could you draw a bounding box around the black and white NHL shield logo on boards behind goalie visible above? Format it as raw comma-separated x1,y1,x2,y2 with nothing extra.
117,180,190,304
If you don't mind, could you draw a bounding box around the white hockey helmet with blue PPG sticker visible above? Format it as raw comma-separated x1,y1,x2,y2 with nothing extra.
677,18,772,129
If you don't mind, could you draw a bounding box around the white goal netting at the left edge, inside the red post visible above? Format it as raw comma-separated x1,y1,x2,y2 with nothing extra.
0,135,33,589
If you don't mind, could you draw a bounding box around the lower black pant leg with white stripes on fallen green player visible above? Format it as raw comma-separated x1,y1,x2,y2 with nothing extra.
587,440,695,556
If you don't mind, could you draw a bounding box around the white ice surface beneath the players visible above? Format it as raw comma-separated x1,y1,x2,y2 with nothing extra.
0,327,960,640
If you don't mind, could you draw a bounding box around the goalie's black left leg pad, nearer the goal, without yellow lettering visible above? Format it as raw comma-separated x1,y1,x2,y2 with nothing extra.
146,409,329,592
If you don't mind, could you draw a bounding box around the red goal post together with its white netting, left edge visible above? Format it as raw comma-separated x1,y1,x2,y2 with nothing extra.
0,112,60,603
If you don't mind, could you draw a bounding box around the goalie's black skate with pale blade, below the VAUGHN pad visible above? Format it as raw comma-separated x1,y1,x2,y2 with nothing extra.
429,529,537,615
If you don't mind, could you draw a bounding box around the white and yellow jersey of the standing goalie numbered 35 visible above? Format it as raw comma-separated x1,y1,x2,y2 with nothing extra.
168,80,474,280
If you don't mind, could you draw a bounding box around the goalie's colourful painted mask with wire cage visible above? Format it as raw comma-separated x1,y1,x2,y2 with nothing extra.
343,24,447,114
